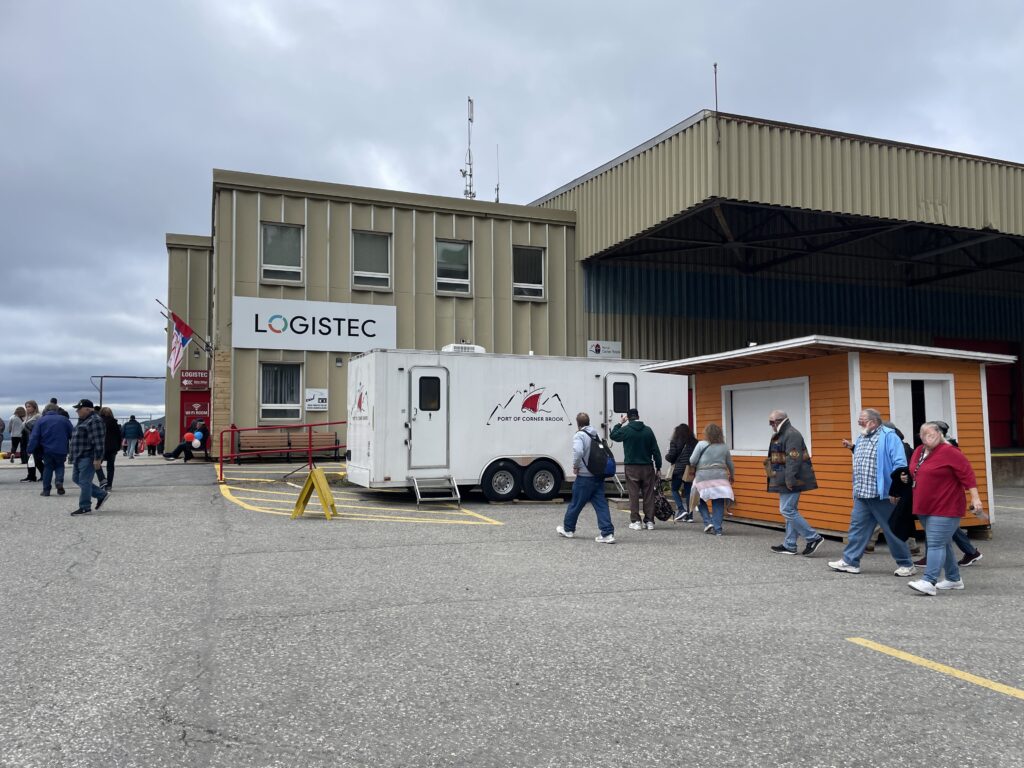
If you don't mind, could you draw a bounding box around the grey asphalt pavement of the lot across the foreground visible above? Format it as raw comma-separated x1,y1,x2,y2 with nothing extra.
0,459,1024,768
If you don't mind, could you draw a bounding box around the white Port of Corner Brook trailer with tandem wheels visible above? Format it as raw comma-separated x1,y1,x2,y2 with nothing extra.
346,344,688,501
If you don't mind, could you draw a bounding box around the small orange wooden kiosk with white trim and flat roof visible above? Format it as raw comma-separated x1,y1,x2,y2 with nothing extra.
645,336,1016,534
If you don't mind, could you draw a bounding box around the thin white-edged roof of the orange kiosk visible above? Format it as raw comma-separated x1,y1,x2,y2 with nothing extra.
643,335,1017,376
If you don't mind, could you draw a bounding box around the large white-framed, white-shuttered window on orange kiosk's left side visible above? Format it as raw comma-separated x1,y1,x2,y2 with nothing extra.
722,376,813,456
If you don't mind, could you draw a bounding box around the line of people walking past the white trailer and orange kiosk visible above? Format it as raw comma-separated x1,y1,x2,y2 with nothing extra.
556,409,986,595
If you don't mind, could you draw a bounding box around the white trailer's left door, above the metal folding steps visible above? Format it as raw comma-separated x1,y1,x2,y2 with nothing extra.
409,366,449,469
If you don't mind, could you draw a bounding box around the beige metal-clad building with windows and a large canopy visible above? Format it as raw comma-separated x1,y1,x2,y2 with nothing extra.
167,112,1024,447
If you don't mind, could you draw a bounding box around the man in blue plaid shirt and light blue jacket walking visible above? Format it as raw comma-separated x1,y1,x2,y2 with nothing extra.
828,409,916,577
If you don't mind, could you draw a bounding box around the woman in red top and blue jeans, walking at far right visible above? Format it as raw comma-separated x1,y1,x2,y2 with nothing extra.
907,422,982,595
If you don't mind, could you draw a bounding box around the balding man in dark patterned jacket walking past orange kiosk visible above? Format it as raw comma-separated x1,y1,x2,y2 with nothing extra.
764,411,824,557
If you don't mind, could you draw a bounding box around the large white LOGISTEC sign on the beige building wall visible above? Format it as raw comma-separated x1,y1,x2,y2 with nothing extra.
231,296,397,352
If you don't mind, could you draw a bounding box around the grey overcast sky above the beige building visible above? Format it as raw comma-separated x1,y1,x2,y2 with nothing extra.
0,0,1024,417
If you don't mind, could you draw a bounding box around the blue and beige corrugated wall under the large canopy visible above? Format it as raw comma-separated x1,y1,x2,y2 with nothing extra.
584,264,1024,359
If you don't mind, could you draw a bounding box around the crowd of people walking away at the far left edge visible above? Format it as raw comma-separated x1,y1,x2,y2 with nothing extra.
0,397,164,515
